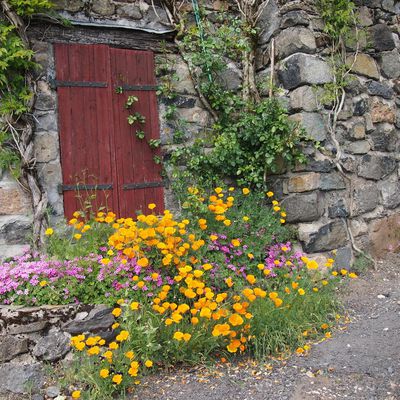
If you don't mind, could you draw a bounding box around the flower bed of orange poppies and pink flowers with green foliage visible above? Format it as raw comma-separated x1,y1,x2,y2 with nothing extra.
0,188,355,399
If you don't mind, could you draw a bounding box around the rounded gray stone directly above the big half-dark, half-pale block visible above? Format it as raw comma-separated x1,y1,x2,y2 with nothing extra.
275,27,317,59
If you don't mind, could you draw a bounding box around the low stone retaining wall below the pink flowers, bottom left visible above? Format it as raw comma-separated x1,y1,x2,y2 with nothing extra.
0,305,115,399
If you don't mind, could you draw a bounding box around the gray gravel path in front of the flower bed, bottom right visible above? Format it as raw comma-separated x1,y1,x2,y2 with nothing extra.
131,256,400,400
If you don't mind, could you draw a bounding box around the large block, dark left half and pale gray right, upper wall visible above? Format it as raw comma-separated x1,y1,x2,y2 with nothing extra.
278,54,332,89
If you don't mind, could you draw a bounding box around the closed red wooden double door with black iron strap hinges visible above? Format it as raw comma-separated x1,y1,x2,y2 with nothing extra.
55,44,164,217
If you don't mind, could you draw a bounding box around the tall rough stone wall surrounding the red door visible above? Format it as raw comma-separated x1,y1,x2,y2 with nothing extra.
0,0,400,266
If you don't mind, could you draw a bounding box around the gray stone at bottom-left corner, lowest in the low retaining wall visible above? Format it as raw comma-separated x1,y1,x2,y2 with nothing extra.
0,363,44,394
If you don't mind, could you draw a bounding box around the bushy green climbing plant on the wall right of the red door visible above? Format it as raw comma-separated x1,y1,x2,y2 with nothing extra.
162,0,307,189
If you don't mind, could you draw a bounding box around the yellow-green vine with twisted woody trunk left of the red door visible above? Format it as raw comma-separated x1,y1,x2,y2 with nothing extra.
0,0,51,247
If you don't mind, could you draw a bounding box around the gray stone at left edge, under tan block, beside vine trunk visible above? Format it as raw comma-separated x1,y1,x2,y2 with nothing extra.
0,215,32,245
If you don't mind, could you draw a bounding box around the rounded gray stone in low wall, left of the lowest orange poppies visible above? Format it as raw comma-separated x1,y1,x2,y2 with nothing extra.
32,331,70,361
